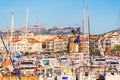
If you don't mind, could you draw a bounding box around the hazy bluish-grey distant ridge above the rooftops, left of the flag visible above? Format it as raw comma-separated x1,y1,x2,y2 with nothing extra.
0,27,74,35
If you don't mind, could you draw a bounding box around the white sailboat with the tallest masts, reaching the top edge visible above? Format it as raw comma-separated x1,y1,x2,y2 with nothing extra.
79,0,101,80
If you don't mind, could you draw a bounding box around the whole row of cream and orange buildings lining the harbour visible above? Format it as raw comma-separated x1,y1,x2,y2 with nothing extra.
0,31,120,54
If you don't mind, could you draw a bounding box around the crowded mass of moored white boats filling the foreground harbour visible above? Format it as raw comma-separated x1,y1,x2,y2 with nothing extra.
1,53,120,80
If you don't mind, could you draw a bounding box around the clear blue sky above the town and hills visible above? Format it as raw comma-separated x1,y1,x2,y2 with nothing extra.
0,0,120,34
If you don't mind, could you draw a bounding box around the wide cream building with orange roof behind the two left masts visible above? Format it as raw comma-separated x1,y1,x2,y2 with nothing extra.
10,37,42,53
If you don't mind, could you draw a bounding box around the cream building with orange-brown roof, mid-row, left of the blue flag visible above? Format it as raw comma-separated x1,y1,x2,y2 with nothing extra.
44,35,68,52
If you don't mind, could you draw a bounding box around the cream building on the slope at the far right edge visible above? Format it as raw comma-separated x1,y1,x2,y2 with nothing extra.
98,31,120,55
